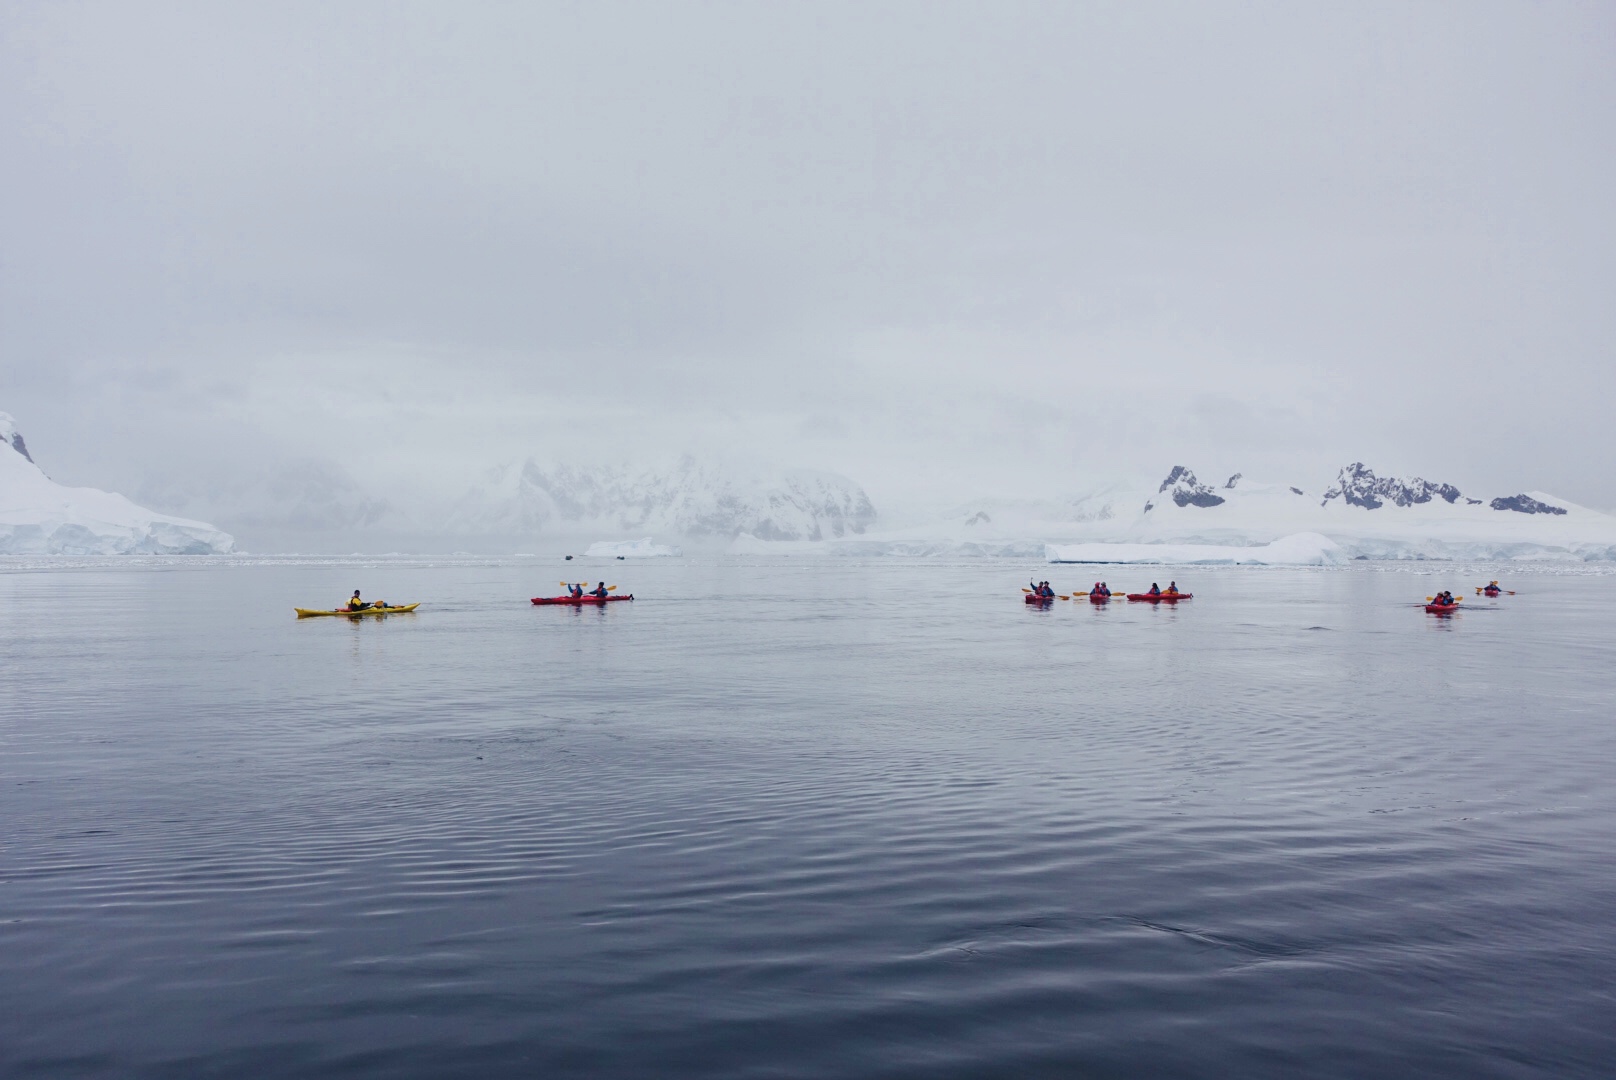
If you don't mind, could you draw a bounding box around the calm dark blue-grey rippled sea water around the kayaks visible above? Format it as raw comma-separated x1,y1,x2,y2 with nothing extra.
0,559,1616,1078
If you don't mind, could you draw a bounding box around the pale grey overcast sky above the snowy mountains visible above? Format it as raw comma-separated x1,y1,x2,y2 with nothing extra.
0,0,1616,509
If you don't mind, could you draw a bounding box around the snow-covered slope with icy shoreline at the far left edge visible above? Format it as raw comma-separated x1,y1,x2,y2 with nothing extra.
0,412,236,555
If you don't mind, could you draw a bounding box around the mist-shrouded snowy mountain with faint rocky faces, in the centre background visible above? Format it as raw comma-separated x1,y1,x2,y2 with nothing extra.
441,458,876,540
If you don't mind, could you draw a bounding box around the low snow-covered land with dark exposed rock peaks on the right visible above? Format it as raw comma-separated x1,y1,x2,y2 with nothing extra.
735,462,1616,563
